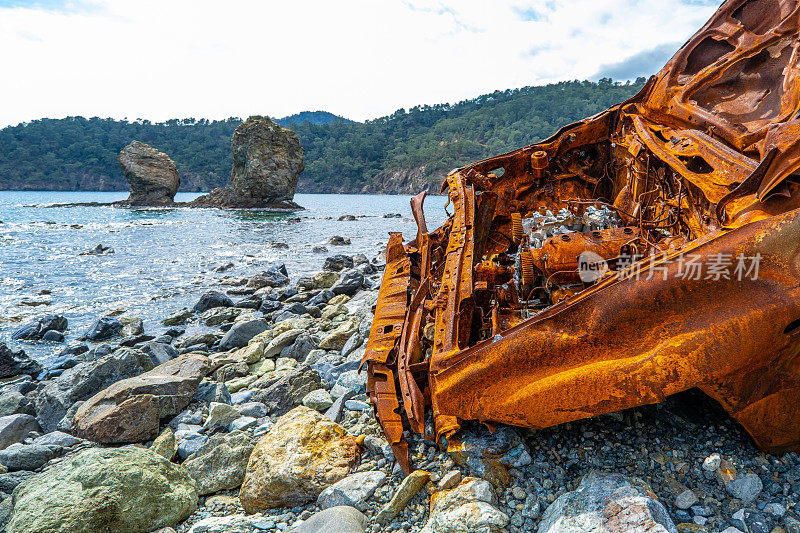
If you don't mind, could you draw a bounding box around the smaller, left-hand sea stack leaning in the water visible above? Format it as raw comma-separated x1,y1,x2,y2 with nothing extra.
119,141,181,205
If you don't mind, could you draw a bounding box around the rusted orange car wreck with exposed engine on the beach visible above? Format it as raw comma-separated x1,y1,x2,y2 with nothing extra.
363,0,800,472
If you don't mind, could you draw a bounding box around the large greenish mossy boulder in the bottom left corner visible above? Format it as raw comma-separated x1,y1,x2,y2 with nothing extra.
8,446,197,533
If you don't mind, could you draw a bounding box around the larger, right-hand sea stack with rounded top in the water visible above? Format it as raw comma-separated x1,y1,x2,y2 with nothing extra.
192,116,305,209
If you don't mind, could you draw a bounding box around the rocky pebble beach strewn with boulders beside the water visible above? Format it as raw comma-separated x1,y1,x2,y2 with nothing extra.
0,238,800,533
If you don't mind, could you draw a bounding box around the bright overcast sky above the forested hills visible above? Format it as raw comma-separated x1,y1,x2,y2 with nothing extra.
0,0,720,127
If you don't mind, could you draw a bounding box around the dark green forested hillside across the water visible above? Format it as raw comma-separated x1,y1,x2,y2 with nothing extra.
0,79,644,192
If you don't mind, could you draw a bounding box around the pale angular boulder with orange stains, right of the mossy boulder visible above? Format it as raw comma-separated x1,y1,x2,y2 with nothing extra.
239,406,360,513
